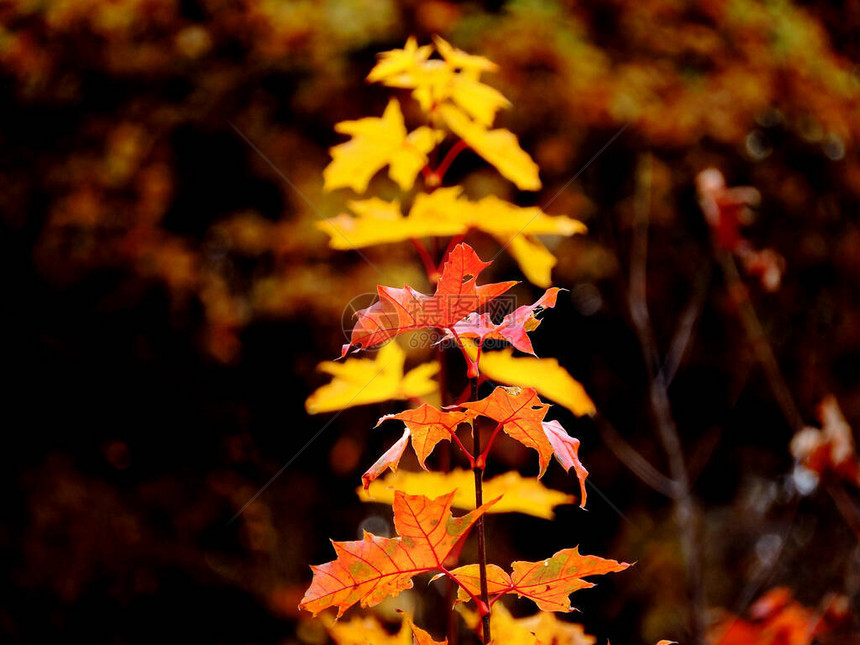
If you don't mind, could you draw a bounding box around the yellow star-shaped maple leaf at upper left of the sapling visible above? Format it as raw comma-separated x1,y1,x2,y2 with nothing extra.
323,99,444,193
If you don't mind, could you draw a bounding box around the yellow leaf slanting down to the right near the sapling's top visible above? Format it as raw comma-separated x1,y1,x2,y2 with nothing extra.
439,103,541,190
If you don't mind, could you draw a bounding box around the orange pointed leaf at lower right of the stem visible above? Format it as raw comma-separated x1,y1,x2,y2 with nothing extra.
451,547,630,612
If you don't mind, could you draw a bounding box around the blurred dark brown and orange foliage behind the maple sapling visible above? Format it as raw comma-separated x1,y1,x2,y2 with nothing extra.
0,0,860,643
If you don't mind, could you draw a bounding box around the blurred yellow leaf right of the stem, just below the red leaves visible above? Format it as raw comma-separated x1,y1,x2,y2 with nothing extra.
474,341,597,417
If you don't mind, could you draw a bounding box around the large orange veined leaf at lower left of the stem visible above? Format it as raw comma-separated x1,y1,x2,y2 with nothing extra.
299,491,495,617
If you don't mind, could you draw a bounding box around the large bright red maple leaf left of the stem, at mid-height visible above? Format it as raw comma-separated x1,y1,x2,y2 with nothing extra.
341,244,516,356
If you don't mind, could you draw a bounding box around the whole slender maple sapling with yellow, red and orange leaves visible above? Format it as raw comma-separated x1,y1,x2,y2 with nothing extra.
300,38,629,645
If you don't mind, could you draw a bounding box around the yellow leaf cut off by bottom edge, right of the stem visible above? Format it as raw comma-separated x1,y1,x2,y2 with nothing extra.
460,602,597,645
